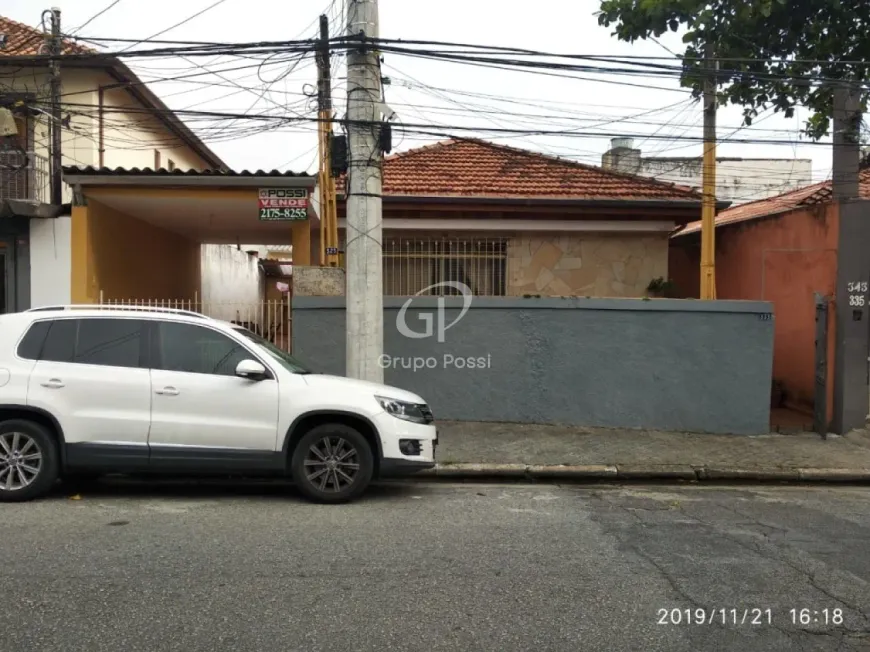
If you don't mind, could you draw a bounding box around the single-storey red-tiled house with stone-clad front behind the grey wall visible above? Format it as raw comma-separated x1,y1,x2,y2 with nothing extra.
339,139,716,297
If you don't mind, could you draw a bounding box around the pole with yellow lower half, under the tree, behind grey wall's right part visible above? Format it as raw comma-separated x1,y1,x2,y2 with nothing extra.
701,43,719,299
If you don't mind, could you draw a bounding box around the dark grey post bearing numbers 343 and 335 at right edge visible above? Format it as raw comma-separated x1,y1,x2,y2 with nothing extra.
831,83,870,434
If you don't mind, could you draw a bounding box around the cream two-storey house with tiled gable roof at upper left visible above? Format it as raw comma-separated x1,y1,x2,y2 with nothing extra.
0,16,226,201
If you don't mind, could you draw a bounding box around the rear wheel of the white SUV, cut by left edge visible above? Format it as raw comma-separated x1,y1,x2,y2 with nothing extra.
0,419,58,502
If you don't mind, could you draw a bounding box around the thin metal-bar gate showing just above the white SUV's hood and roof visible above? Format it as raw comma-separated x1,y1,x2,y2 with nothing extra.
100,292,292,352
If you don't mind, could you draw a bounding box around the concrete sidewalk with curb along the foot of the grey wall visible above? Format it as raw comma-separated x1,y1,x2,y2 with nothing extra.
420,421,870,482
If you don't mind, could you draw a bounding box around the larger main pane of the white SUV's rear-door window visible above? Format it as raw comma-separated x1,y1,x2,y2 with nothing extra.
73,319,144,367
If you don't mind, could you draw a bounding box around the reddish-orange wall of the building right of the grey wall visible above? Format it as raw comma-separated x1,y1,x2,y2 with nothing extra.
669,205,839,410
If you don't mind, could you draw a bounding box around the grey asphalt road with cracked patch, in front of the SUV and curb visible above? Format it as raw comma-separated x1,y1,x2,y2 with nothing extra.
0,485,870,652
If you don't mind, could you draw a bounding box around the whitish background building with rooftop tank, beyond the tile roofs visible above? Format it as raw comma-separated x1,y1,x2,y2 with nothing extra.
601,138,813,205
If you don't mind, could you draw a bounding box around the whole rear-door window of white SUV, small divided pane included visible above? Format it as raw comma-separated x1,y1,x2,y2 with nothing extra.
40,318,145,367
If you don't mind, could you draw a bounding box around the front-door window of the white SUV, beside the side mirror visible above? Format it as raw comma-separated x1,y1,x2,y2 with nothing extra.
155,322,253,376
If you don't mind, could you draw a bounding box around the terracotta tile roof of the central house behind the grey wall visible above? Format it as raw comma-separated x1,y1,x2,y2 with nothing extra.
339,139,701,202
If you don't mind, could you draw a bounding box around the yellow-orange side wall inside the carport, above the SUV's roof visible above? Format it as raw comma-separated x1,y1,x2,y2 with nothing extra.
71,199,200,303
